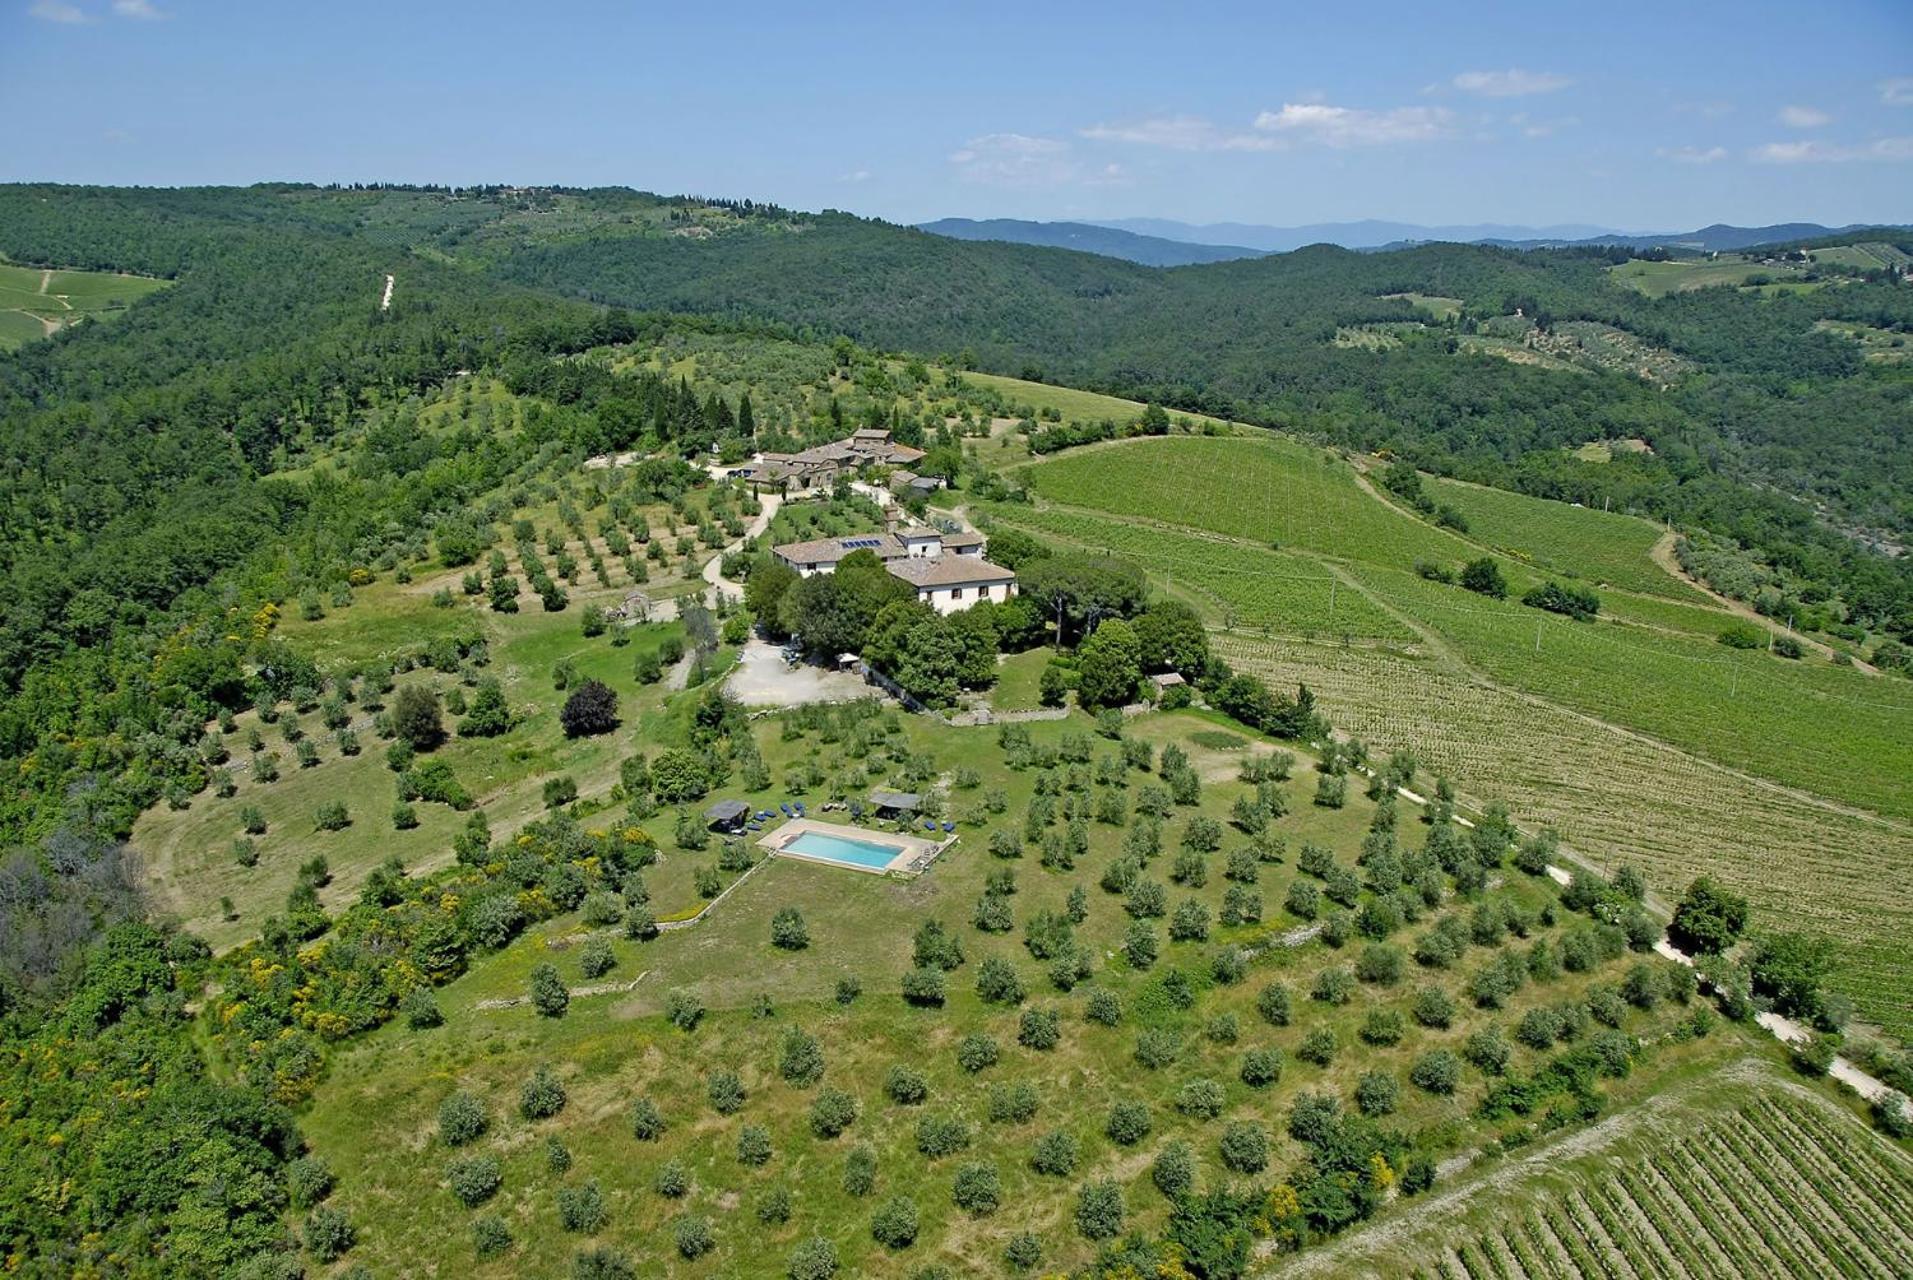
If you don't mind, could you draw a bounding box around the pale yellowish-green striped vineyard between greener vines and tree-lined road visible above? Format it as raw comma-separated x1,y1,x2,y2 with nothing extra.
1215,635,1913,1035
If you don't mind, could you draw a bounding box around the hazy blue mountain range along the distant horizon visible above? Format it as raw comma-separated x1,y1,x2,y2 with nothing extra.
920,218,1905,266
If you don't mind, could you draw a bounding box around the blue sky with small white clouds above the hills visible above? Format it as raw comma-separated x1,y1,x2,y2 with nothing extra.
0,0,1913,230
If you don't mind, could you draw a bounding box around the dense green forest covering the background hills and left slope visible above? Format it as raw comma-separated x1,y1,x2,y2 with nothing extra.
0,186,1913,1274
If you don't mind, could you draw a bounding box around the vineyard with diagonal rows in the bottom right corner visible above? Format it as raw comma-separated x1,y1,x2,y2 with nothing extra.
1270,1068,1913,1280
